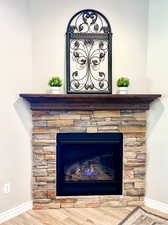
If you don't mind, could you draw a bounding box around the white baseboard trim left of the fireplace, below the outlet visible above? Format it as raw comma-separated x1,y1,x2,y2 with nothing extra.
0,201,32,224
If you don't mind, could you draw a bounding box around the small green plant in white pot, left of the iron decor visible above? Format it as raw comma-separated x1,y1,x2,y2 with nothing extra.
48,77,63,94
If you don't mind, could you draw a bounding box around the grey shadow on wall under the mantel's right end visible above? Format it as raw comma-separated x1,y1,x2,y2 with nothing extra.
148,99,165,136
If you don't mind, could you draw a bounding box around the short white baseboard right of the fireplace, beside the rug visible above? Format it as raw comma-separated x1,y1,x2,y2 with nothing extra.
145,198,168,213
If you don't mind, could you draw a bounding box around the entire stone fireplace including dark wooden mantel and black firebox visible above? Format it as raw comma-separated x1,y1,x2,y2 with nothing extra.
21,94,160,209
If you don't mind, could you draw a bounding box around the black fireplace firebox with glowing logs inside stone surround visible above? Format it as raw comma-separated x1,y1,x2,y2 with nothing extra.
56,133,123,196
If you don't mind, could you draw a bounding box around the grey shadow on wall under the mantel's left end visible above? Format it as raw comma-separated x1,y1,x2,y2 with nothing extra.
13,98,32,137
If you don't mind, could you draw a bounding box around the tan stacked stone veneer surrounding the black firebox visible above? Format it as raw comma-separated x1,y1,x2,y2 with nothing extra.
32,110,146,209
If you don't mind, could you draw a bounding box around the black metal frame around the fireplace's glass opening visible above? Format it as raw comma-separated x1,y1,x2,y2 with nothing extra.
56,133,123,196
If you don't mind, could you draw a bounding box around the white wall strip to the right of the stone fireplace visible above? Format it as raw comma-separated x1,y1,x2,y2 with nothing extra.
147,0,168,204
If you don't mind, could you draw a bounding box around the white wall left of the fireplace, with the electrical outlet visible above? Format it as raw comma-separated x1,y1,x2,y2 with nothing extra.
0,0,32,213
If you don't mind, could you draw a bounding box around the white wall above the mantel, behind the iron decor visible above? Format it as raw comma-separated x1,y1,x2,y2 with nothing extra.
31,0,148,93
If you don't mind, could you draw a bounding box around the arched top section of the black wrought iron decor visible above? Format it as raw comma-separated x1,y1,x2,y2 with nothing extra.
67,9,112,34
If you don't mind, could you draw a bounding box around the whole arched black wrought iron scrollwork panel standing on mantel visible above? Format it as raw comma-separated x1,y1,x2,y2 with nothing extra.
66,9,112,94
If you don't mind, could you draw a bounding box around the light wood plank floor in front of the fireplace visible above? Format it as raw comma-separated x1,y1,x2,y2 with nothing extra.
1,207,168,225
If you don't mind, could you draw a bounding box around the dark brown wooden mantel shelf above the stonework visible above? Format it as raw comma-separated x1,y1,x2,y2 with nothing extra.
20,94,161,111
